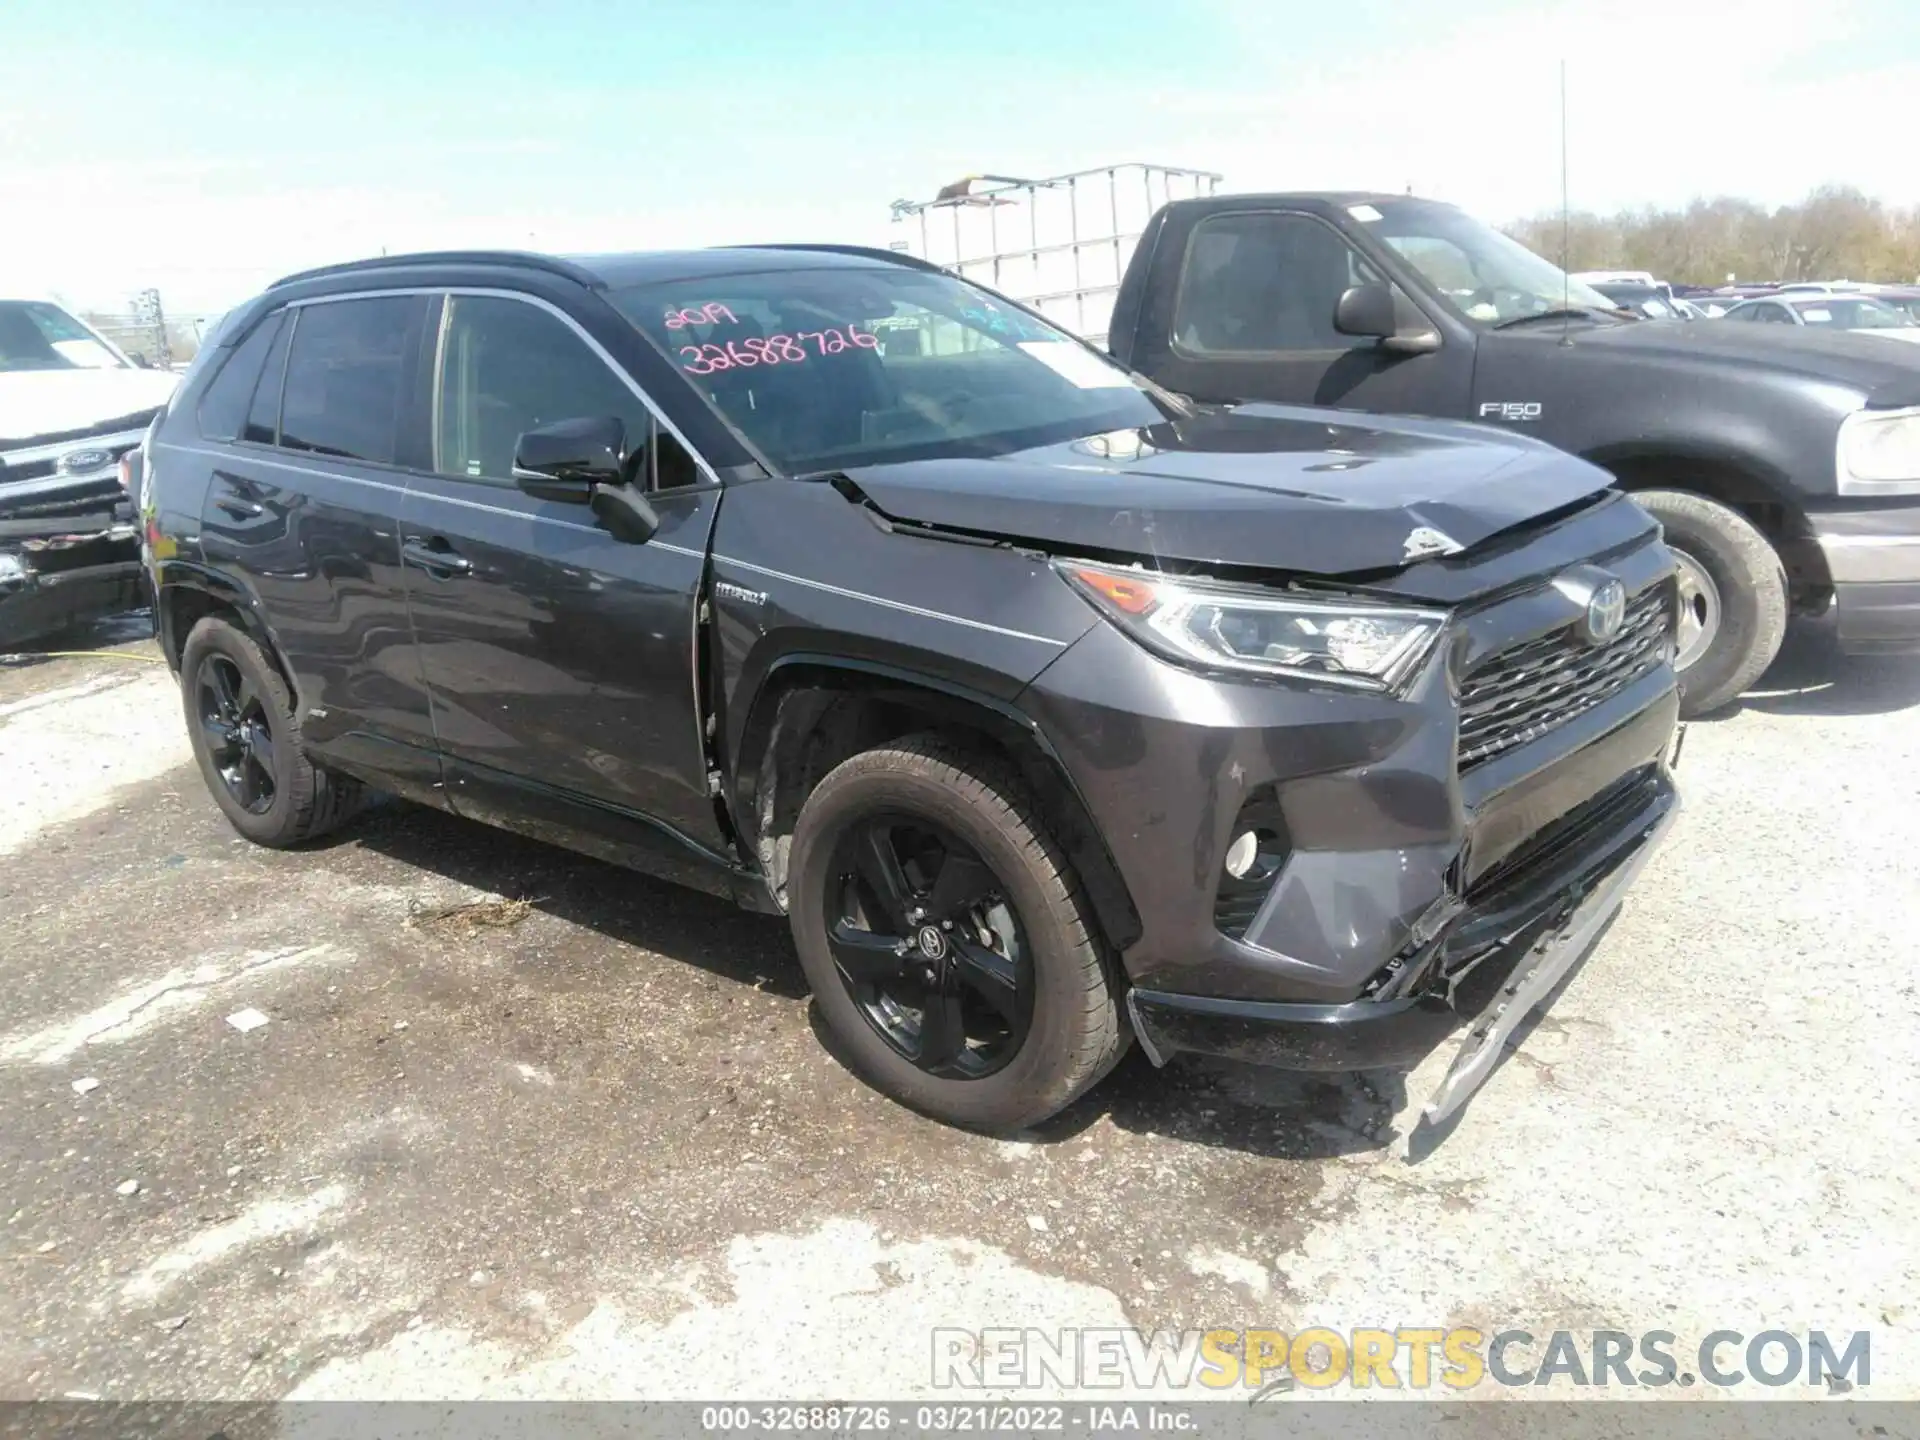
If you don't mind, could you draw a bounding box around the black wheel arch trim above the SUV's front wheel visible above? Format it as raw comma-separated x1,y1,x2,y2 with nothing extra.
730,651,1140,954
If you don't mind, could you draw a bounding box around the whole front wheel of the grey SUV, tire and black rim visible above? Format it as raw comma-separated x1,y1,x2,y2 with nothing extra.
787,735,1127,1133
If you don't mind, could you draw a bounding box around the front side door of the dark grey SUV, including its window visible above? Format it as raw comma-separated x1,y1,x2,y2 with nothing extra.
401,294,724,870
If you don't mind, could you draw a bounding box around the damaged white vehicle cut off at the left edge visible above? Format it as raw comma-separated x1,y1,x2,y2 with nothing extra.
0,292,179,651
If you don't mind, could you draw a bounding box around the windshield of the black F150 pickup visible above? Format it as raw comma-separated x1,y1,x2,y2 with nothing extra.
1350,200,1615,324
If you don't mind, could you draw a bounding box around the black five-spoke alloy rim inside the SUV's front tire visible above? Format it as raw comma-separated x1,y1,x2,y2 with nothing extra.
822,814,1035,1079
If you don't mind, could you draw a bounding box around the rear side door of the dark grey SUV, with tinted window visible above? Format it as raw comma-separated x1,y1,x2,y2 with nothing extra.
200,294,440,803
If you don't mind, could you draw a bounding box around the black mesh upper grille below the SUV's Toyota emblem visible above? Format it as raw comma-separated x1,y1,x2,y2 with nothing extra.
1459,582,1674,770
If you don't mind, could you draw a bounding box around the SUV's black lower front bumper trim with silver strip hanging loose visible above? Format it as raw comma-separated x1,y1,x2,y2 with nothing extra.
1127,766,1680,1069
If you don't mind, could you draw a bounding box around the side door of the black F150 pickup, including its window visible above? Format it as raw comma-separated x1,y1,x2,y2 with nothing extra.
1133,209,1473,415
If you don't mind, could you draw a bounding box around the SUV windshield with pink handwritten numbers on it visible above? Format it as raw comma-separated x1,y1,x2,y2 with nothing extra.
611,265,1175,472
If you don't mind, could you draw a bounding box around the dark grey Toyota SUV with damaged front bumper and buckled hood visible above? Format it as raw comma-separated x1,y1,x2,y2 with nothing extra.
146,246,1676,1131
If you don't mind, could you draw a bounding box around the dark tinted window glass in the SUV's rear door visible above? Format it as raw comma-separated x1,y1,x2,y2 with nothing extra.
280,296,424,465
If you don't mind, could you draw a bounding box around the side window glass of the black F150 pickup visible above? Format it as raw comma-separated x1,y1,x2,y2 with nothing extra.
1173,211,1384,355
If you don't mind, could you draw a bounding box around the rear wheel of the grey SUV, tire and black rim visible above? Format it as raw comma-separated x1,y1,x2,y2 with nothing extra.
180,616,363,849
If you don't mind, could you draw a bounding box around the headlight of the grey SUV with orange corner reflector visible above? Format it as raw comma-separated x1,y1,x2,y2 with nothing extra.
1054,561,1446,691
